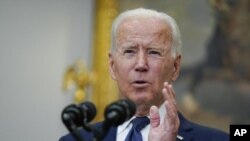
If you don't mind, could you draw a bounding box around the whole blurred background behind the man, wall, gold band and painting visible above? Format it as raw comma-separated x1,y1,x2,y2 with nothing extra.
0,0,250,141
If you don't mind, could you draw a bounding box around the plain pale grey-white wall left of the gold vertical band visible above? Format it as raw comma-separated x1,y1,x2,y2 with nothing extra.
0,0,94,141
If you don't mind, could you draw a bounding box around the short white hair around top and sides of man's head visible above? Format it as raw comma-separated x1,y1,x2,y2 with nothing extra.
110,8,181,57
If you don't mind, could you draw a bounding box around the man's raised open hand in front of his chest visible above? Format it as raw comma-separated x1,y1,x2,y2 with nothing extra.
148,82,180,141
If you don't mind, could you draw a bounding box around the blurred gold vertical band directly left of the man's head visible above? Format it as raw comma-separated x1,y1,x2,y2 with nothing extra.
92,0,118,121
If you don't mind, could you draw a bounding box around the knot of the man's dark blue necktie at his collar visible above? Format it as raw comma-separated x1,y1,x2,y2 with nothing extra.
131,117,149,131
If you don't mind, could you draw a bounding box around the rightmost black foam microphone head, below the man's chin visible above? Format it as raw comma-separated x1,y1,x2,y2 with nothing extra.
104,99,136,129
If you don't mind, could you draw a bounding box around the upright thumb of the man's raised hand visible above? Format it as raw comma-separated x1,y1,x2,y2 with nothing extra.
149,106,160,128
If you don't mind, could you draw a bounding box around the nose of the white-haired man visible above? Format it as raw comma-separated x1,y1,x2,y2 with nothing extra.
135,51,148,72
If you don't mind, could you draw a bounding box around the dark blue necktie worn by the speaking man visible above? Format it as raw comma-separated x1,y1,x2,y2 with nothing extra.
125,117,149,141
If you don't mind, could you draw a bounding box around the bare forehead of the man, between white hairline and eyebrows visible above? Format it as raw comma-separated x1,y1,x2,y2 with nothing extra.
116,17,171,45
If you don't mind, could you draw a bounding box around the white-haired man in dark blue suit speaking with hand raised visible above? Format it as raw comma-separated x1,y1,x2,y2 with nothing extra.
60,8,229,141
